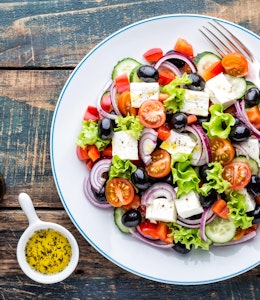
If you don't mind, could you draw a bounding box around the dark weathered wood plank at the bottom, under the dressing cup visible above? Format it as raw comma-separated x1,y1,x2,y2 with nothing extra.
0,210,260,300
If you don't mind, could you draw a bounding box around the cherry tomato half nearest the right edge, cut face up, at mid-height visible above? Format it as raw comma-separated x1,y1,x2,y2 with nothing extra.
222,162,252,190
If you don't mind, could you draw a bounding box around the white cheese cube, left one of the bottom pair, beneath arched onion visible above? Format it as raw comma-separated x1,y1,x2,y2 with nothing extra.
145,198,177,223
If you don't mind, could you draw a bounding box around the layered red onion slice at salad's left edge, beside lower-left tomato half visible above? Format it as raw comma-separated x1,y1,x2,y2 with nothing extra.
89,158,112,193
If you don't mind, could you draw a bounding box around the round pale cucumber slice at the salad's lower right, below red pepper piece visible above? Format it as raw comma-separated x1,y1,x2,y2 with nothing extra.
205,217,236,244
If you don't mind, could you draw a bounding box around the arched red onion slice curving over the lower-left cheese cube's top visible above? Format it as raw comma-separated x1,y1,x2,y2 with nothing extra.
141,182,176,206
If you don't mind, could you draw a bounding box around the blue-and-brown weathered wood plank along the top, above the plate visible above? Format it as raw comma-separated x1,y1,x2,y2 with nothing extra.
0,0,260,67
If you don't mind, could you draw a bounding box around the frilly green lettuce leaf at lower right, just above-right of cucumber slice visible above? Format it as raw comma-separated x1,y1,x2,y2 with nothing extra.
227,191,254,229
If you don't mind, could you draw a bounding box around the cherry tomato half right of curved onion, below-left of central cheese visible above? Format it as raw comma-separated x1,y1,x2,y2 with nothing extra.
145,149,171,178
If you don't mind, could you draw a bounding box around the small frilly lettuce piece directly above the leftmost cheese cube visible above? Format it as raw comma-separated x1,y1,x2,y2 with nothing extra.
114,116,144,140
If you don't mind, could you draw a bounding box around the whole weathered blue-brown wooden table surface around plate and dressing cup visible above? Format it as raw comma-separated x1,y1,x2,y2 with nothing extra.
0,0,260,300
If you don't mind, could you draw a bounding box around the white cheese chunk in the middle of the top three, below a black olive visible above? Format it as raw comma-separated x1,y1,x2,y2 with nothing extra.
180,90,209,117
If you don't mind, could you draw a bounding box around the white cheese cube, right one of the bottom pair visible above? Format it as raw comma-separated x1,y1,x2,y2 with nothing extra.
175,191,203,218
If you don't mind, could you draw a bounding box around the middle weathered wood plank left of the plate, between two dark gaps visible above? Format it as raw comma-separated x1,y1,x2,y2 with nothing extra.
0,70,71,207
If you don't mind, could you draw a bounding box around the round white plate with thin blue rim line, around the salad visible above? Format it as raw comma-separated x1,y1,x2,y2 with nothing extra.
51,15,260,285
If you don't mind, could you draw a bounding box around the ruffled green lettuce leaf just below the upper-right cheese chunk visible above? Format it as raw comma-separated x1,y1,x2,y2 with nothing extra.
202,103,236,139
